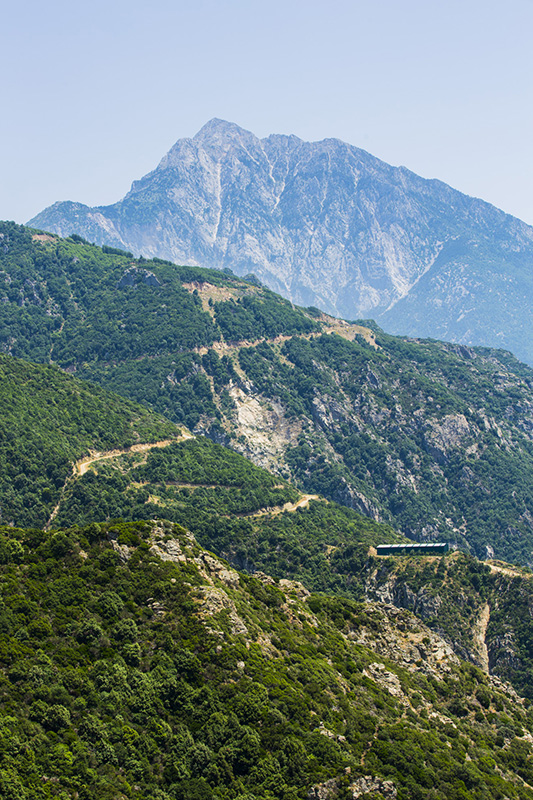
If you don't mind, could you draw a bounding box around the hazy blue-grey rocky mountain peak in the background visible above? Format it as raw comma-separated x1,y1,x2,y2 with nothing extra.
29,119,533,364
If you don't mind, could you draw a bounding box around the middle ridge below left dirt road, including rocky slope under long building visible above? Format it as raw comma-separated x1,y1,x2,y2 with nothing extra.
47,439,533,699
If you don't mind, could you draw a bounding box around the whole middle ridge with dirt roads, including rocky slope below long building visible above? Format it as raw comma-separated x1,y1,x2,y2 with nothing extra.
0,356,533,708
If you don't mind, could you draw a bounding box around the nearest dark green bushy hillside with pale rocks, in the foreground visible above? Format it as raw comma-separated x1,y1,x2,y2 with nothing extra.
0,522,533,800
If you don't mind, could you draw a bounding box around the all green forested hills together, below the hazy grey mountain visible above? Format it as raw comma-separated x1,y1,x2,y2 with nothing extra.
5,224,533,800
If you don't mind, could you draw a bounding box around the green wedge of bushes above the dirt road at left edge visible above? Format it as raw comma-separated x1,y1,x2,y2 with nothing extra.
0,354,180,525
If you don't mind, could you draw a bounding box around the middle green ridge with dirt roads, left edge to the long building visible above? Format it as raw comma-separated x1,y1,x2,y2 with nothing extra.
0,356,403,595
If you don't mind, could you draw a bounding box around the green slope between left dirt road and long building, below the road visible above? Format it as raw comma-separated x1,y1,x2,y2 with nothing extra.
56,438,402,597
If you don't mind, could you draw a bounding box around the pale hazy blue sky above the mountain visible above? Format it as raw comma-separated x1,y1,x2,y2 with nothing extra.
4,0,533,224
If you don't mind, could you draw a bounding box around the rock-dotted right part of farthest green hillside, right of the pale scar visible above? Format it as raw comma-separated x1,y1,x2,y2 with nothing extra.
239,333,533,563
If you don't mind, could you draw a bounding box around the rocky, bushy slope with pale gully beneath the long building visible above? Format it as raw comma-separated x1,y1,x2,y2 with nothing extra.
362,552,533,696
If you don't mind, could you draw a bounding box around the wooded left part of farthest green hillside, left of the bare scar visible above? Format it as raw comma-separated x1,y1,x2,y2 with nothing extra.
0,223,319,428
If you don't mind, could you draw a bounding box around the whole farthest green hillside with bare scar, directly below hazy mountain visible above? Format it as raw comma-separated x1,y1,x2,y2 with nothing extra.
0,223,533,563
